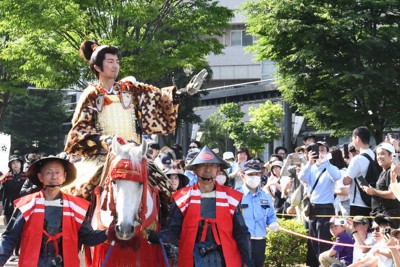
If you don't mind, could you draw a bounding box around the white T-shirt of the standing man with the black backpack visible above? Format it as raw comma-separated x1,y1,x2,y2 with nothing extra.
346,148,375,207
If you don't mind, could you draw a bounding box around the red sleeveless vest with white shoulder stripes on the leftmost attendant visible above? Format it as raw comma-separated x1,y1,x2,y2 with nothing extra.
14,191,89,267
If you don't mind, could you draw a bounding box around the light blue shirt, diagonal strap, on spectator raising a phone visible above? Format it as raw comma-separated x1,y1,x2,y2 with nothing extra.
299,161,341,204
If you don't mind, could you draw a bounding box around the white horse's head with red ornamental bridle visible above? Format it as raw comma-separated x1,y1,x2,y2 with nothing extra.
109,137,147,240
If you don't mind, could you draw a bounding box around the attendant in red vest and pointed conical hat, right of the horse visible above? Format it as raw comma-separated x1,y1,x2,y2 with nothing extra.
149,146,251,267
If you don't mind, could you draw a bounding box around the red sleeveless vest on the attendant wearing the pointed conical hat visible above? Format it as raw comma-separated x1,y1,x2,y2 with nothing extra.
173,183,242,267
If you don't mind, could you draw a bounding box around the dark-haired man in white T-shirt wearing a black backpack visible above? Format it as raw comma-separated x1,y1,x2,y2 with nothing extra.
343,126,375,216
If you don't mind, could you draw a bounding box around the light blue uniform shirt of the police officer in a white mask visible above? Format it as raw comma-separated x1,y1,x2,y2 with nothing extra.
238,184,278,238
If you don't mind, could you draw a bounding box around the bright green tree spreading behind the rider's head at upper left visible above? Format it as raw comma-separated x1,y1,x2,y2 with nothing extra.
0,0,233,135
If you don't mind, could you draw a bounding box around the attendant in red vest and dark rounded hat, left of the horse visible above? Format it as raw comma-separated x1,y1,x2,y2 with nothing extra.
0,157,107,267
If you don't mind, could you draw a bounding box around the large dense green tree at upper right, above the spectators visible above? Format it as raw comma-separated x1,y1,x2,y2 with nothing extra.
244,0,400,142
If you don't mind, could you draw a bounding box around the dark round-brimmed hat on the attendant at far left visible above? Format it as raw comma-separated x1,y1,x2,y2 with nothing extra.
27,156,76,186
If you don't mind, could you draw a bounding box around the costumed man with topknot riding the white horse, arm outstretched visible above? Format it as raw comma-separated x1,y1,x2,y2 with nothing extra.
64,41,207,201
